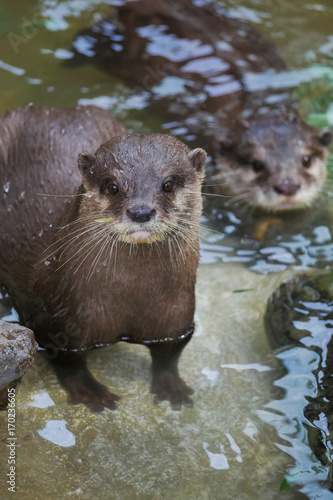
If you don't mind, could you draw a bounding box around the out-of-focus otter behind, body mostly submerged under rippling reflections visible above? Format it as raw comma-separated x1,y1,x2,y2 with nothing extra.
66,0,331,212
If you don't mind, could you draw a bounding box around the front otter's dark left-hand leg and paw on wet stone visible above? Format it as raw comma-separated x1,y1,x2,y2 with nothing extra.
52,352,120,412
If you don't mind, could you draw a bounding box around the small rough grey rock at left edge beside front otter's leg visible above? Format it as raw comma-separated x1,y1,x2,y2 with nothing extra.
0,320,37,409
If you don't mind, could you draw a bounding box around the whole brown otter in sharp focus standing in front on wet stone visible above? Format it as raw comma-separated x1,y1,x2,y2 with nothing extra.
0,107,206,410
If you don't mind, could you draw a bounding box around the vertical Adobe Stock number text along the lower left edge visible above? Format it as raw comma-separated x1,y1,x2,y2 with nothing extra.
6,388,17,493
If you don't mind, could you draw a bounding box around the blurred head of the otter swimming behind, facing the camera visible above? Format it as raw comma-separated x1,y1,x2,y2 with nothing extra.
214,117,332,211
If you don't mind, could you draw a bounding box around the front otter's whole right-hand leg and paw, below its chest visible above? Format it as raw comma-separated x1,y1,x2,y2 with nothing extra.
148,328,193,410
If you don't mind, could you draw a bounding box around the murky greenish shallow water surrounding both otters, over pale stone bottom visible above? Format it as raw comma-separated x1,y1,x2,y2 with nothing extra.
0,0,333,500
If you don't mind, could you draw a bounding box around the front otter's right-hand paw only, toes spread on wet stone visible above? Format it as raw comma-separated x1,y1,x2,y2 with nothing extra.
150,372,193,410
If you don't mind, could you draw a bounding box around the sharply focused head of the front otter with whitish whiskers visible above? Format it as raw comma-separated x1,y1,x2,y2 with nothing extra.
78,134,206,244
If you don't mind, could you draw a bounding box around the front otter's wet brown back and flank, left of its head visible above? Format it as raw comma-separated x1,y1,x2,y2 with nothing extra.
0,106,126,288
